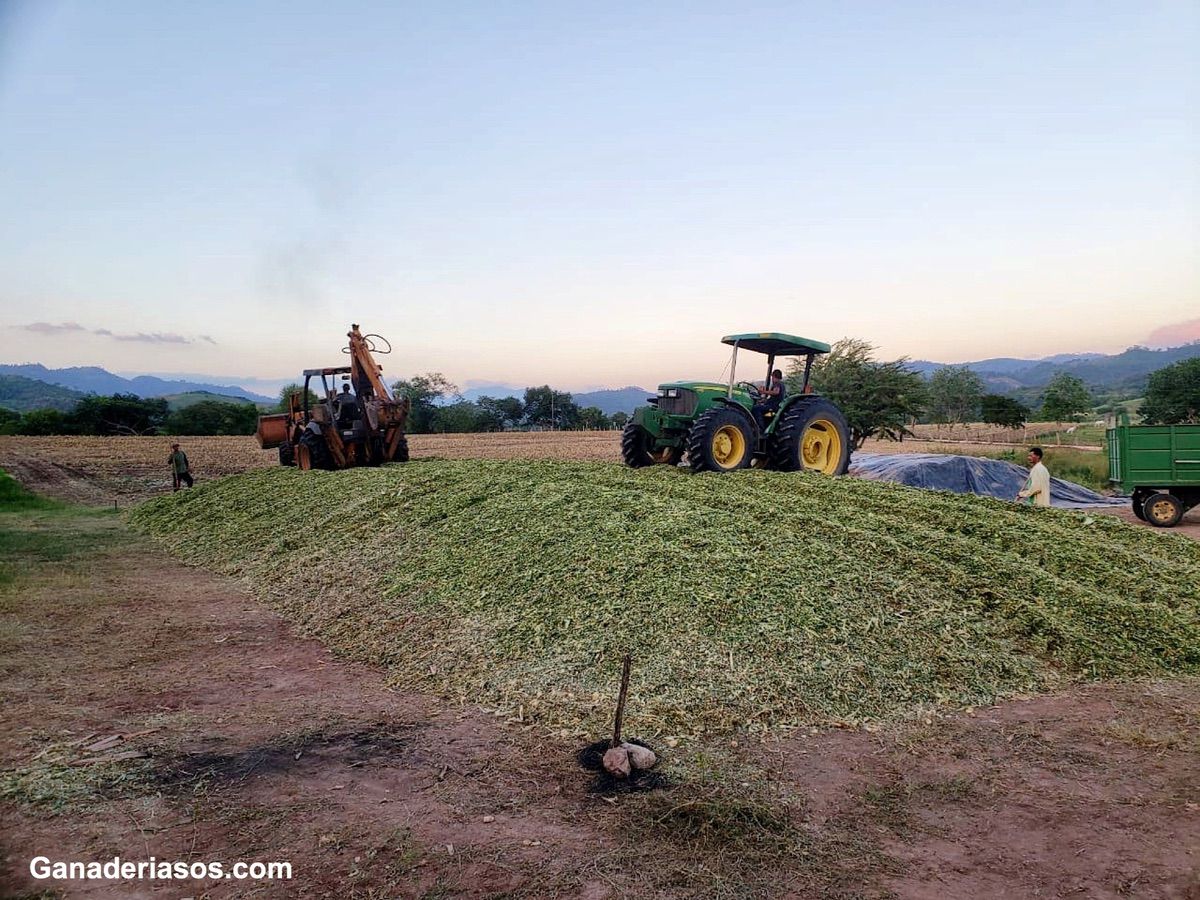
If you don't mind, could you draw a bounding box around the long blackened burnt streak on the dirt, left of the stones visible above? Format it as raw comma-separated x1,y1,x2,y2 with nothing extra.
156,724,416,788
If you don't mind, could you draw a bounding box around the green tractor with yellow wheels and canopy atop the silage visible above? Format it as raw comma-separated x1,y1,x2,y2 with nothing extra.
620,334,851,475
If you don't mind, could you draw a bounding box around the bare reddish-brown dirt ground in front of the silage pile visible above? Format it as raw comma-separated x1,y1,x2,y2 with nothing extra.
0,475,1200,900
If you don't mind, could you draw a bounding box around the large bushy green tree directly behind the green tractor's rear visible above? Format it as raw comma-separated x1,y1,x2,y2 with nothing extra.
787,337,925,449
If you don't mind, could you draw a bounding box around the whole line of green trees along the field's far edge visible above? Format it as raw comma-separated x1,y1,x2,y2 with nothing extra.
0,352,1200,446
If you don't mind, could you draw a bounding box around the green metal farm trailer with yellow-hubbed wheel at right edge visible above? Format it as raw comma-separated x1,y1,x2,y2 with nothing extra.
1108,425,1200,528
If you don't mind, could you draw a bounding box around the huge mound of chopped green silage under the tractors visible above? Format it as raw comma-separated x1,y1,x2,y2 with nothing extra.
133,461,1200,736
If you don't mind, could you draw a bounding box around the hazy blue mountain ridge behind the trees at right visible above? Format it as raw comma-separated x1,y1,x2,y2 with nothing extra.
911,341,1200,394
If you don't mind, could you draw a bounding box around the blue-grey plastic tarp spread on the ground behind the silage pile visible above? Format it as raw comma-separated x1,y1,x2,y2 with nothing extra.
850,454,1126,509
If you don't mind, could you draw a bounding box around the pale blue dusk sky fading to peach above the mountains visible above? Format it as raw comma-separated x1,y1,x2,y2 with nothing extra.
0,0,1200,390
